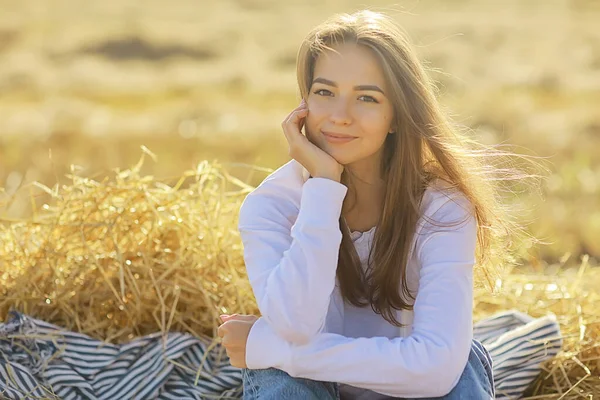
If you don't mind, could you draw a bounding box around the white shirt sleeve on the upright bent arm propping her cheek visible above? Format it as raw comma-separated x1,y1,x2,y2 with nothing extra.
238,178,347,347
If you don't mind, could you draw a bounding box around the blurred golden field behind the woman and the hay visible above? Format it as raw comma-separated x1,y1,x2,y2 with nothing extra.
0,0,600,265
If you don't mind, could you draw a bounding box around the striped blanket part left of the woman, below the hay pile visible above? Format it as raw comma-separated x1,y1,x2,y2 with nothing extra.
0,311,242,400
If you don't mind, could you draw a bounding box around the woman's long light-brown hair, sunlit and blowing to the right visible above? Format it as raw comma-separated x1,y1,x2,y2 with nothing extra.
297,10,535,326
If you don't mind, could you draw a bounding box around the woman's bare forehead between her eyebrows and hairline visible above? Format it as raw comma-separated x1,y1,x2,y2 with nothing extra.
313,43,385,87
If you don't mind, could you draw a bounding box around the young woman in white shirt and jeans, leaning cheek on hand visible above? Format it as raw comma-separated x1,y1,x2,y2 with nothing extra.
219,11,528,399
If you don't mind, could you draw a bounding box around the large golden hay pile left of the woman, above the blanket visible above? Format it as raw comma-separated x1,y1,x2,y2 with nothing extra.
0,150,258,343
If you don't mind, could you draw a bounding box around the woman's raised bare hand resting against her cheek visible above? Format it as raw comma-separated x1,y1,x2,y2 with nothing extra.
281,100,344,182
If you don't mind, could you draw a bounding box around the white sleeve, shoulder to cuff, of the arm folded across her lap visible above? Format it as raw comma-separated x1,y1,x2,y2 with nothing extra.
246,195,477,398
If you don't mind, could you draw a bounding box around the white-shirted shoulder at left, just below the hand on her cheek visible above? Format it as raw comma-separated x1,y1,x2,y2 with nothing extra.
239,159,309,225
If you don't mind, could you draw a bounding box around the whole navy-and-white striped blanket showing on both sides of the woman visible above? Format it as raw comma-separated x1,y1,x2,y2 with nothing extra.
0,310,562,400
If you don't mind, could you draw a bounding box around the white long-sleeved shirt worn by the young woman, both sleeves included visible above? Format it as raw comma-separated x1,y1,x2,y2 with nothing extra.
239,160,477,397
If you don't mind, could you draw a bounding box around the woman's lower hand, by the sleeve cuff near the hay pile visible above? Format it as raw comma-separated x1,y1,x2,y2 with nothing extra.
217,314,258,368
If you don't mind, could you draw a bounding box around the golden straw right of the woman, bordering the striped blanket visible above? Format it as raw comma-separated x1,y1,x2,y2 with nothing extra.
474,256,600,399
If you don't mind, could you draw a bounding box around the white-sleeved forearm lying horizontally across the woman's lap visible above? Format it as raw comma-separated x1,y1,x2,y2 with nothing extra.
246,320,471,398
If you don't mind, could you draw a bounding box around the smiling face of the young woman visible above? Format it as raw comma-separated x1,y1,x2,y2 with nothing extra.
305,43,393,165
